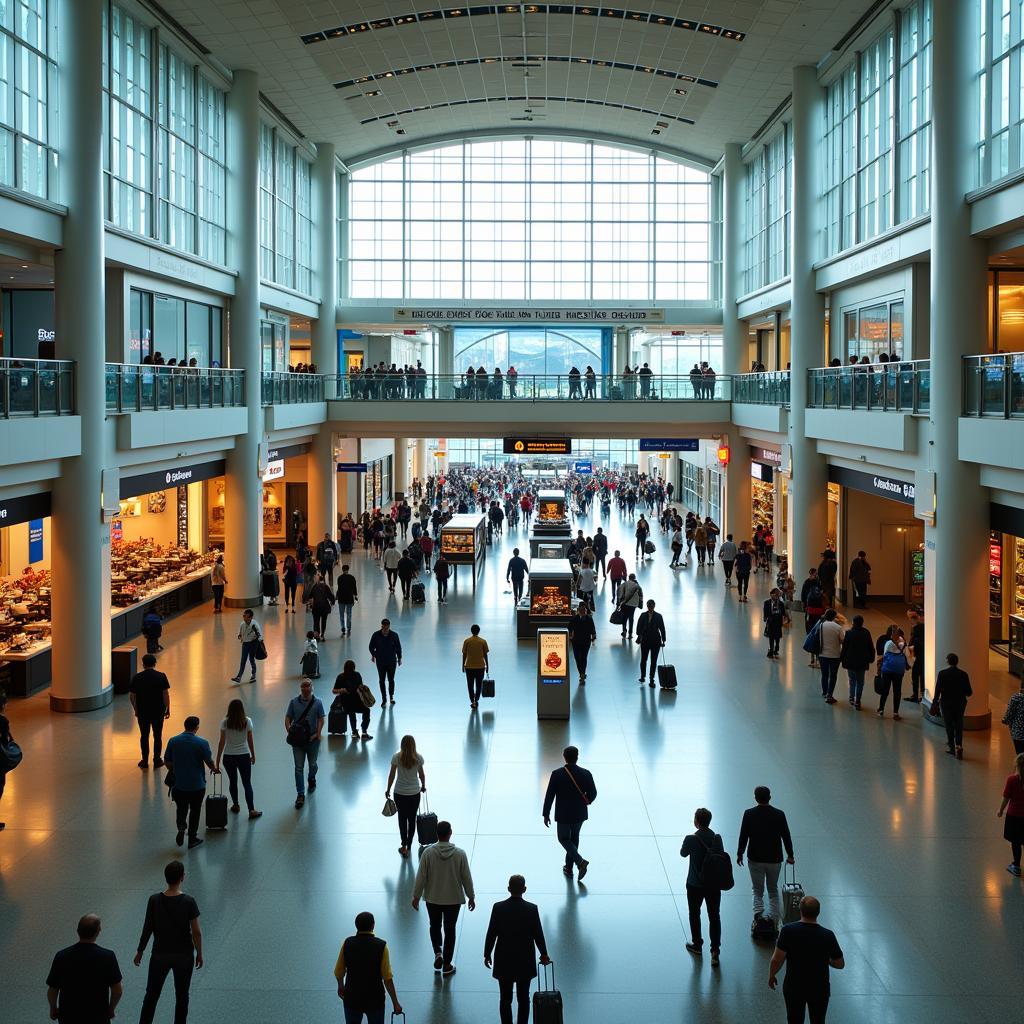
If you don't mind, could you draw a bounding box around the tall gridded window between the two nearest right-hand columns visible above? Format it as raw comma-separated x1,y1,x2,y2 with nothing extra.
822,0,933,256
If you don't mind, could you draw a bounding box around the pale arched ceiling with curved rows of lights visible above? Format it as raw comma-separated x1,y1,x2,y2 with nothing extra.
160,0,873,163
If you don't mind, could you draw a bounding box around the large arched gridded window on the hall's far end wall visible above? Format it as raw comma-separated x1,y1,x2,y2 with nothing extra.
347,138,717,302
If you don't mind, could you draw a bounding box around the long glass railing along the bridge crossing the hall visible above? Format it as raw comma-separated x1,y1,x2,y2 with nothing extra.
327,374,732,402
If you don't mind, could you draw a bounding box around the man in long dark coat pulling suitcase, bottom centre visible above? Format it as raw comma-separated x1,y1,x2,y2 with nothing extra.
483,874,551,1024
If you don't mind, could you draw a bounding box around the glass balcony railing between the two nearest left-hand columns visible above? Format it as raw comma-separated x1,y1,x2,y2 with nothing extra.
106,362,246,413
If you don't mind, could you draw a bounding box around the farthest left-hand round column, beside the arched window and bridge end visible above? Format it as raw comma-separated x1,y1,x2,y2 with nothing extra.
306,142,338,540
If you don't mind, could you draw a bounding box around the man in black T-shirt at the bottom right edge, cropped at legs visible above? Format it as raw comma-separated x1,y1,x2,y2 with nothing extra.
768,896,846,1024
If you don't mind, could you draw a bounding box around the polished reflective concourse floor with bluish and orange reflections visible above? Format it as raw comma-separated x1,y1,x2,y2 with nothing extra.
0,505,1024,1024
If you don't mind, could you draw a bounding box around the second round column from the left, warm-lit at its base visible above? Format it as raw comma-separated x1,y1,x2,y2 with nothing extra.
224,71,263,607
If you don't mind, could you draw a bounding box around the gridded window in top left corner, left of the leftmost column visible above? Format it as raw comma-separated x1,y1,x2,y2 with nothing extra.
0,0,59,201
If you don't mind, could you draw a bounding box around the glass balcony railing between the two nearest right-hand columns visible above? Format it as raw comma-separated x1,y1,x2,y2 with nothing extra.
807,359,932,414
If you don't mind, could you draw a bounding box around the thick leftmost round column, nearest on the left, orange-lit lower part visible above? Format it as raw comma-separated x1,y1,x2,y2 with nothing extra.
50,0,109,712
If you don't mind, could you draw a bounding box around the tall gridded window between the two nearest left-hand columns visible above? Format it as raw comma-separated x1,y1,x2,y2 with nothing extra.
103,3,227,265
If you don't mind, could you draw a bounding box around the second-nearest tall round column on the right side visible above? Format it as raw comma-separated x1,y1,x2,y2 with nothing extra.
787,66,828,593
